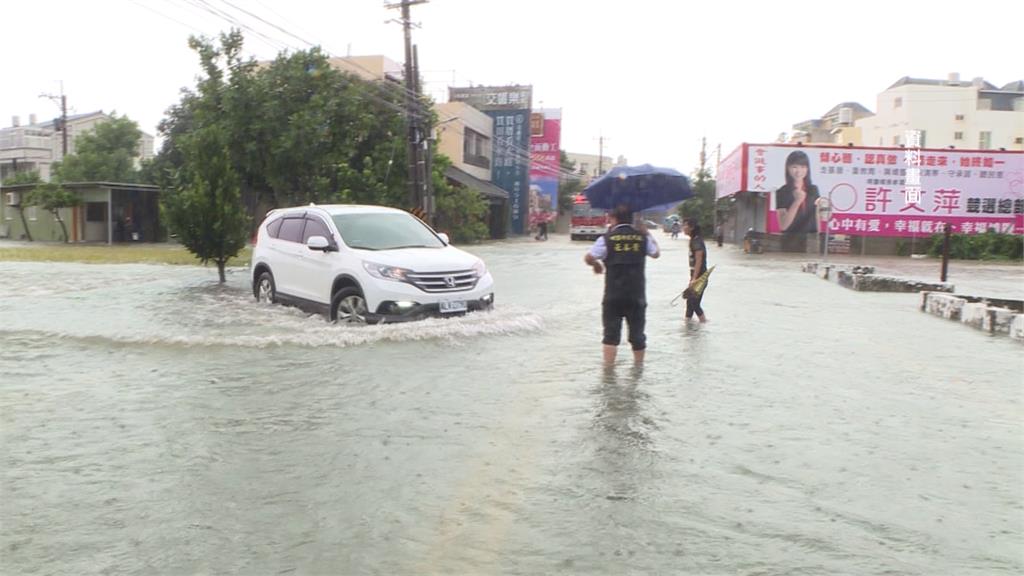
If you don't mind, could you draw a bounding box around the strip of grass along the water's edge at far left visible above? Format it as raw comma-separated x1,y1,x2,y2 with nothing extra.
0,244,252,269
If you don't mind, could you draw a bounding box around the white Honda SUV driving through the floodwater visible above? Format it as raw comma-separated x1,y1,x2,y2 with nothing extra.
251,205,495,323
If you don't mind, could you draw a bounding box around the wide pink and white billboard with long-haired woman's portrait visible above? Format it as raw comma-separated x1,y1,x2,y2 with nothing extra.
720,145,1024,237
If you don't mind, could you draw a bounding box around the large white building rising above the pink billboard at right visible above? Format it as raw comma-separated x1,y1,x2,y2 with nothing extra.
856,74,1024,150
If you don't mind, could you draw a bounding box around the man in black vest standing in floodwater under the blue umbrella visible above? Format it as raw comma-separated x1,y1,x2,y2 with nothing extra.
584,206,660,365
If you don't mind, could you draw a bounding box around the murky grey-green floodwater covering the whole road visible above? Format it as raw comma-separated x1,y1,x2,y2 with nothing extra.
0,233,1024,575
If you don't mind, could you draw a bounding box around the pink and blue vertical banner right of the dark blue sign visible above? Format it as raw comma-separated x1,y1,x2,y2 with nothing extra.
528,109,562,231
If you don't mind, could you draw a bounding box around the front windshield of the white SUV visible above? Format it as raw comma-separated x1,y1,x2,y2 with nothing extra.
332,212,444,250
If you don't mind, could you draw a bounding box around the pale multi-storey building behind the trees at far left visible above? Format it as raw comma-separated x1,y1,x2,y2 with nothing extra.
0,111,154,181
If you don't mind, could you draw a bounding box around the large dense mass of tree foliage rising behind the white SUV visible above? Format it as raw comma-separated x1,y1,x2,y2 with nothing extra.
150,31,415,223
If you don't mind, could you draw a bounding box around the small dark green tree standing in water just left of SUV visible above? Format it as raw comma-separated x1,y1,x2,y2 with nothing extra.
164,125,249,283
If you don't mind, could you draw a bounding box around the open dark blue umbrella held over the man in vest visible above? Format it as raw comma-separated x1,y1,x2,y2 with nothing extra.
583,164,693,212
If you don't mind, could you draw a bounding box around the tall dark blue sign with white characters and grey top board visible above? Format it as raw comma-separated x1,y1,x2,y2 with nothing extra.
449,86,534,234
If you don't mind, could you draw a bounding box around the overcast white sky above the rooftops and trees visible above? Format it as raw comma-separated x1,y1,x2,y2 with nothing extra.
0,0,1024,173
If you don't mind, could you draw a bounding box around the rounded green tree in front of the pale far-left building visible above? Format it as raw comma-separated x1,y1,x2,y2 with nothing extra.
54,115,142,182
